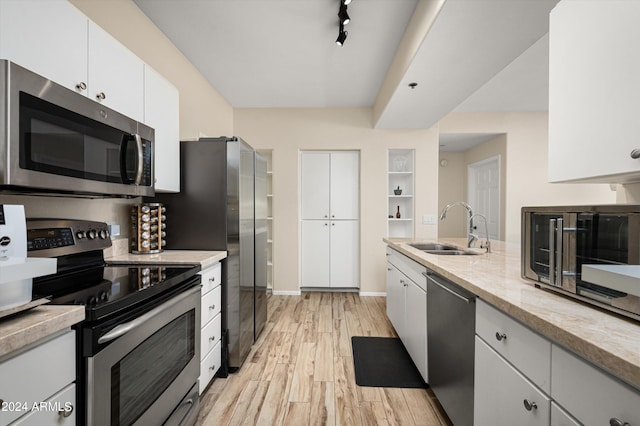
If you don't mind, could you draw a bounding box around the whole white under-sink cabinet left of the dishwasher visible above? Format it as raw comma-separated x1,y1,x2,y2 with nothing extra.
387,248,429,383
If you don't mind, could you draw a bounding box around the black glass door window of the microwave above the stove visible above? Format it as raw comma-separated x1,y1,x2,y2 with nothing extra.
20,92,127,183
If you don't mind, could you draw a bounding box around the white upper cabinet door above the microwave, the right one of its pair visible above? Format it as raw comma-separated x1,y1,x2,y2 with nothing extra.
87,21,144,121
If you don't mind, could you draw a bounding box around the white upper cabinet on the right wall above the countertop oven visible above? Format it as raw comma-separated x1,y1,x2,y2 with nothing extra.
549,0,640,183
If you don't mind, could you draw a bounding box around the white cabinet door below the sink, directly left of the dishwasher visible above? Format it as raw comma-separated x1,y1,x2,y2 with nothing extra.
404,278,429,383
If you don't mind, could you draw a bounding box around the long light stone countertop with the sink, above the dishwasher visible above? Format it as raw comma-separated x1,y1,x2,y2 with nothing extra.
384,238,640,389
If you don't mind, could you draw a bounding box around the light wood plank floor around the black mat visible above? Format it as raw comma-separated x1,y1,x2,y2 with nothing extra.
198,293,450,426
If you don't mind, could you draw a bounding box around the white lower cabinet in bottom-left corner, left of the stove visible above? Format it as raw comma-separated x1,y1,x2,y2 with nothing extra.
0,330,76,426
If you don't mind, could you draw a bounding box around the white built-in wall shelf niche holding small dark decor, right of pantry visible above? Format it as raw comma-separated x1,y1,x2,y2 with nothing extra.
387,149,415,238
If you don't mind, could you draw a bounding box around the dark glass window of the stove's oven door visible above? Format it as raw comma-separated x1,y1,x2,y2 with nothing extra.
111,310,196,425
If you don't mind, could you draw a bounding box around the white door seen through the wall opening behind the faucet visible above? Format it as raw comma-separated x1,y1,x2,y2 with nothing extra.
467,155,501,240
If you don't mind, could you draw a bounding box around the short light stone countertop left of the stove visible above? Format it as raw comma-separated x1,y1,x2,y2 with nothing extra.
0,305,84,360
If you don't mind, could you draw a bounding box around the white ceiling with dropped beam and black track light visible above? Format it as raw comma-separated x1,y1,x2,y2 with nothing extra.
134,0,558,148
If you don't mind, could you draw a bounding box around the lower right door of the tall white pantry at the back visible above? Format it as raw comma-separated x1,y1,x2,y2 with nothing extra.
329,220,360,288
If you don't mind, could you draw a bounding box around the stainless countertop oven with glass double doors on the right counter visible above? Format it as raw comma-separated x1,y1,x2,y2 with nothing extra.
521,204,640,320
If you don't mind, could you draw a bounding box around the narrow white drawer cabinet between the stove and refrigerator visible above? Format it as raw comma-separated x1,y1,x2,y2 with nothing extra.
200,263,222,394
